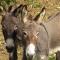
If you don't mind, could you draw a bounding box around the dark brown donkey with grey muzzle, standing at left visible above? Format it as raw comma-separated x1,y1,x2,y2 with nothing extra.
1,5,23,60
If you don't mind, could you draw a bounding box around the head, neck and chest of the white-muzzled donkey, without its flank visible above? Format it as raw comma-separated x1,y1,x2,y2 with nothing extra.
23,7,48,60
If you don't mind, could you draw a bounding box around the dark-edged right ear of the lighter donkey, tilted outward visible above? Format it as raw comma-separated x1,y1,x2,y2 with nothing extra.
33,6,45,24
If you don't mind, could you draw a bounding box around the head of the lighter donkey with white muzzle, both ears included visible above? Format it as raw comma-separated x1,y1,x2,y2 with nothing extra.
23,6,45,57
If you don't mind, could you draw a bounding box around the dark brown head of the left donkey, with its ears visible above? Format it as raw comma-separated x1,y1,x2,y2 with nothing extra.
1,5,23,48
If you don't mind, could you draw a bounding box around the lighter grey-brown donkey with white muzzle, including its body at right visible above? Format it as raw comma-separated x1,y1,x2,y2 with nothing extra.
23,5,60,60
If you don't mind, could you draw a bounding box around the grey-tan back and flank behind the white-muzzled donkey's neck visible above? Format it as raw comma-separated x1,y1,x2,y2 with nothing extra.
45,12,60,52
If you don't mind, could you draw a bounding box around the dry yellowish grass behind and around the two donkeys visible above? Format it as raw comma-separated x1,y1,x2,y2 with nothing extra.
0,0,60,60
